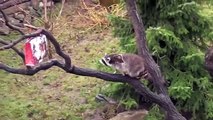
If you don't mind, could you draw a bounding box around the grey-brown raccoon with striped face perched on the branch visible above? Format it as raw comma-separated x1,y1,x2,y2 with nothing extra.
100,53,149,79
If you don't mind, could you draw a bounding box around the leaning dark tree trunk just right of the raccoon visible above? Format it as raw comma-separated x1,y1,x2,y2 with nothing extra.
126,0,186,120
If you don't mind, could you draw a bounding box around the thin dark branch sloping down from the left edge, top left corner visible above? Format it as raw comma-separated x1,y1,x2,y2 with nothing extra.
0,9,24,35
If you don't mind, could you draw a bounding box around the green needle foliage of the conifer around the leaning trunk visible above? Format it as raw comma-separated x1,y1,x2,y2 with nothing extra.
101,0,213,120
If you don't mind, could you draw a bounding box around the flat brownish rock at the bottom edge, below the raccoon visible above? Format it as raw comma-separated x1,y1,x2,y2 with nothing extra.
109,110,148,120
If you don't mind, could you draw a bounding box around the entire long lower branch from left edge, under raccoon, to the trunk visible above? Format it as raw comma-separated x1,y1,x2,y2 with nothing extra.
0,60,166,109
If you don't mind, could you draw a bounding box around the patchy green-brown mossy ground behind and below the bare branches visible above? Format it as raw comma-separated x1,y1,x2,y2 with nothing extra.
0,0,119,120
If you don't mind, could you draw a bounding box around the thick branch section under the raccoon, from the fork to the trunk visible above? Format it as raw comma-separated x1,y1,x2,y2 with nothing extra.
69,66,170,106
